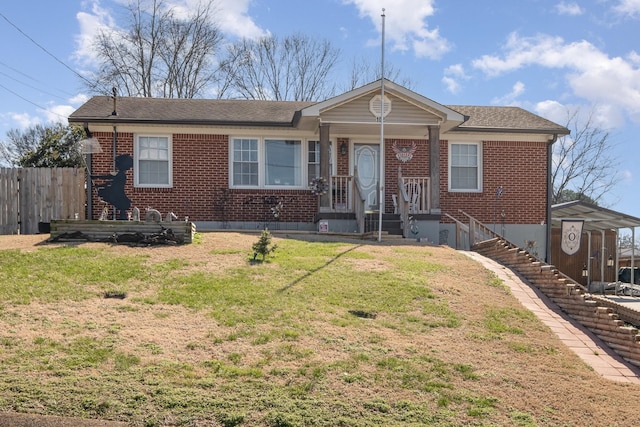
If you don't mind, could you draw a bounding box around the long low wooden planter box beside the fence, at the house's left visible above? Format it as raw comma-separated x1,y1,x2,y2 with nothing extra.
50,219,196,243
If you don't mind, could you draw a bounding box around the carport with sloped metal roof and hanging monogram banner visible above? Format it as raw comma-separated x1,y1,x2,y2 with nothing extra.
551,200,640,285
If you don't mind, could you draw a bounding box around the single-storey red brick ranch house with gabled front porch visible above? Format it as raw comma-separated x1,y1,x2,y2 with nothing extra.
69,80,569,260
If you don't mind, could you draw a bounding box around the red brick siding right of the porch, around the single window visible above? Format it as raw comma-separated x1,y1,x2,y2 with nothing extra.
440,141,547,224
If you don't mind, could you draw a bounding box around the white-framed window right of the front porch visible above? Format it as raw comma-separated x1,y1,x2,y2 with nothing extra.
449,142,482,192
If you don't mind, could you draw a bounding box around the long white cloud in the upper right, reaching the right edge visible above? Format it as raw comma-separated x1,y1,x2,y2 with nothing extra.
473,33,640,123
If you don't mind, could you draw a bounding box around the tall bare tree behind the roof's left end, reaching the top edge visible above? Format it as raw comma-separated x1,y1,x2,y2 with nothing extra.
93,0,222,98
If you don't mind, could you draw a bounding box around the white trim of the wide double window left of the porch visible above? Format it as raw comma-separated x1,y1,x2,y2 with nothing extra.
228,135,335,190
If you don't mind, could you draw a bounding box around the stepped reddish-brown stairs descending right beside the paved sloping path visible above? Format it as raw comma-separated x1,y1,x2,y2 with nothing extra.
471,238,640,366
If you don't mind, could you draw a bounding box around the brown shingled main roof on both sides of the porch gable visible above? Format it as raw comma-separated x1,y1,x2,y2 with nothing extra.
69,96,569,134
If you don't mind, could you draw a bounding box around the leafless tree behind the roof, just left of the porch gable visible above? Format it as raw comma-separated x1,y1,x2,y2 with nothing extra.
218,34,340,101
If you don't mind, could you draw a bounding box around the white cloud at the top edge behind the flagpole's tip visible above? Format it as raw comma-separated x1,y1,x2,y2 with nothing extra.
343,0,451,59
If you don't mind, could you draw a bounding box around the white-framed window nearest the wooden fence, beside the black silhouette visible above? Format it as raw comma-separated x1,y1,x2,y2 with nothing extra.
133,135,173,188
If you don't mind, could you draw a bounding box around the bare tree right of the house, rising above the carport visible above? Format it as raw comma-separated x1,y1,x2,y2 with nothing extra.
551,110,620,204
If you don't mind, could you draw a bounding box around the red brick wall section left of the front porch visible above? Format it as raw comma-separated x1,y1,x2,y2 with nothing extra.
91,132,318,222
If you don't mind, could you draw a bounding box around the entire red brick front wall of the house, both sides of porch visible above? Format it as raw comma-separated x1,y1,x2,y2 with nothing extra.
91,132,547,224
